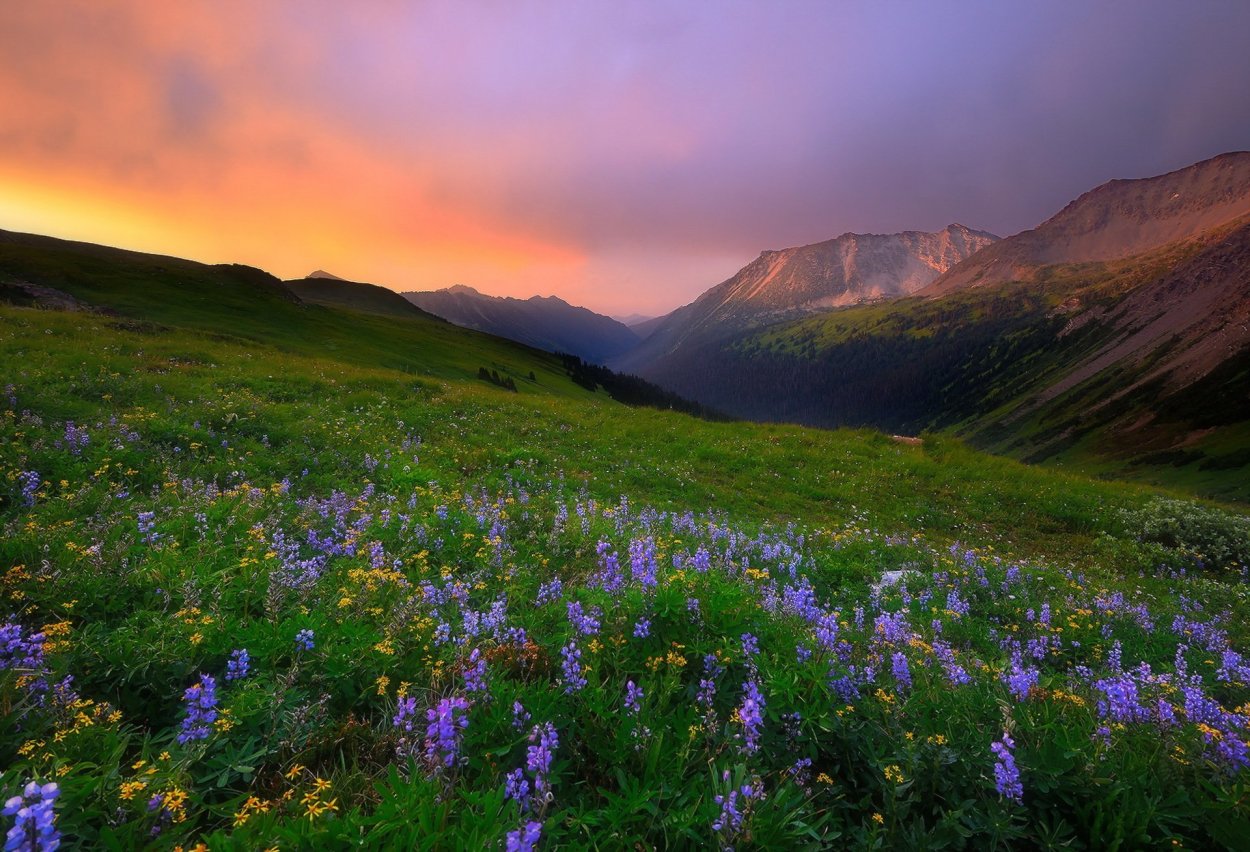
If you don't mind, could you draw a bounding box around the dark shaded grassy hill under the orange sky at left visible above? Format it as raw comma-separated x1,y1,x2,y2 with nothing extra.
0,226,589,399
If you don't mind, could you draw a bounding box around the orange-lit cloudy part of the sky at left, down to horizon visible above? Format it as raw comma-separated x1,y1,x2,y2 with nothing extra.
0,4,585,295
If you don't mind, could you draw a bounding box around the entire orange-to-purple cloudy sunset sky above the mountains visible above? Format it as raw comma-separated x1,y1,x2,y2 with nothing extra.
0,0,1250,315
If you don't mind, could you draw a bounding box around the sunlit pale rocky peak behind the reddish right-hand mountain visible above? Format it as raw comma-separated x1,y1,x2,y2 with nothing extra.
618,224,999,371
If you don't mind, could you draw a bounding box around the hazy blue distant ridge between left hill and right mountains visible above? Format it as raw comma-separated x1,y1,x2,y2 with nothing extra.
401,285,639,364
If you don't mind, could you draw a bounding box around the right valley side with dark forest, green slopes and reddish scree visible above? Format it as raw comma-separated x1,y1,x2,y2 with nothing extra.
616,152,1250,497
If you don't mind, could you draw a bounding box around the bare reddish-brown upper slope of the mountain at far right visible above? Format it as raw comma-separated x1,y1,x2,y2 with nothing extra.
921,151,1250,297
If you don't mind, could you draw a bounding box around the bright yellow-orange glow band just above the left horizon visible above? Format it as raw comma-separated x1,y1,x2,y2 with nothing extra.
0,163,584,296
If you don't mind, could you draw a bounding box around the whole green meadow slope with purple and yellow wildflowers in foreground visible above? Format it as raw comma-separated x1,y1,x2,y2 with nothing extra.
0,241,1250,850
